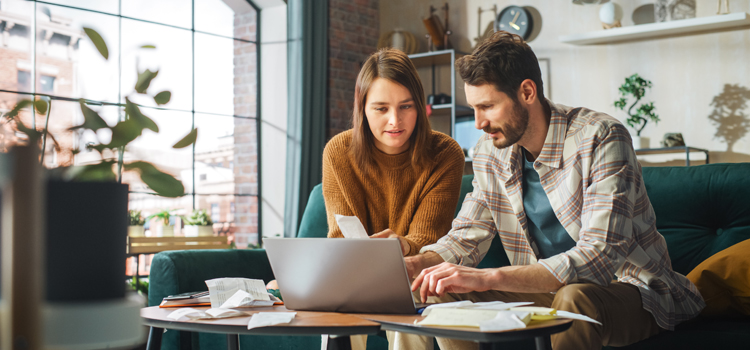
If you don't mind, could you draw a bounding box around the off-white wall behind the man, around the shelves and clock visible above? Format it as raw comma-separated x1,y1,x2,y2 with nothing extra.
380,0,750,165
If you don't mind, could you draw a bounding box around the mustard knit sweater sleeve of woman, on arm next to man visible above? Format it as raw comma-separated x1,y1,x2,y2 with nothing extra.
405,138,465,255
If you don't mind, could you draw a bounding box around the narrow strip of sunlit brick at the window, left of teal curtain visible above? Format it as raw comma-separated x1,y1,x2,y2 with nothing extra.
234,11,258,248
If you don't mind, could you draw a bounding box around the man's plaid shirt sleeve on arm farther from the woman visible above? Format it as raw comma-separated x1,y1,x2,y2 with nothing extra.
539,124,641,286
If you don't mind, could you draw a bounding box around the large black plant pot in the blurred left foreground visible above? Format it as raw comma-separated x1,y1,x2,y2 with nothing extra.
45,180,129,302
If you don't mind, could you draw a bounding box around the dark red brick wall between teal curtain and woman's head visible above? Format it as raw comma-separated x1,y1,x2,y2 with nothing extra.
326,0,380,139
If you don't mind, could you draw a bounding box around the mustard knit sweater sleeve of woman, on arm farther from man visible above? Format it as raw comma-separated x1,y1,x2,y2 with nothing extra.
323,143,354,238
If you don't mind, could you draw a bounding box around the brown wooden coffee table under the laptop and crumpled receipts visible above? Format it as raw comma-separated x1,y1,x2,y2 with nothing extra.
141,306,380,350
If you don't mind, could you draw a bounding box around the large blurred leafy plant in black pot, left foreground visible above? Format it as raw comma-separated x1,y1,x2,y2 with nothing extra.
3,28,197,302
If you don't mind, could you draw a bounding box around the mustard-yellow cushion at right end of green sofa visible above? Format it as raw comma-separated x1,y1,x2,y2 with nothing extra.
687,239,750,316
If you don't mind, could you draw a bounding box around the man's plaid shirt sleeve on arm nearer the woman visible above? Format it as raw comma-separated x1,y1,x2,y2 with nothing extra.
420,176,497,266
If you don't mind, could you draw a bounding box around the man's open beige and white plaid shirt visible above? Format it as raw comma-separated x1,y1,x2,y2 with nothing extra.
421,101,705,330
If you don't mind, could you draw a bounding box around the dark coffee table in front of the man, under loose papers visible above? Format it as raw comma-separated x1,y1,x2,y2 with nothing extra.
359,314,573,350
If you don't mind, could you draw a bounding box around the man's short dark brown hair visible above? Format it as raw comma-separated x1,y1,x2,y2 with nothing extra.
456,31,545,105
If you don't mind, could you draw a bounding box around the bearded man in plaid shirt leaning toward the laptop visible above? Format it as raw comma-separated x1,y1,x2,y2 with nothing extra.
406,32,705,349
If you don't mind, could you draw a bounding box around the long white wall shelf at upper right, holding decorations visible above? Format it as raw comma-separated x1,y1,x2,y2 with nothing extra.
560,12,750,45
